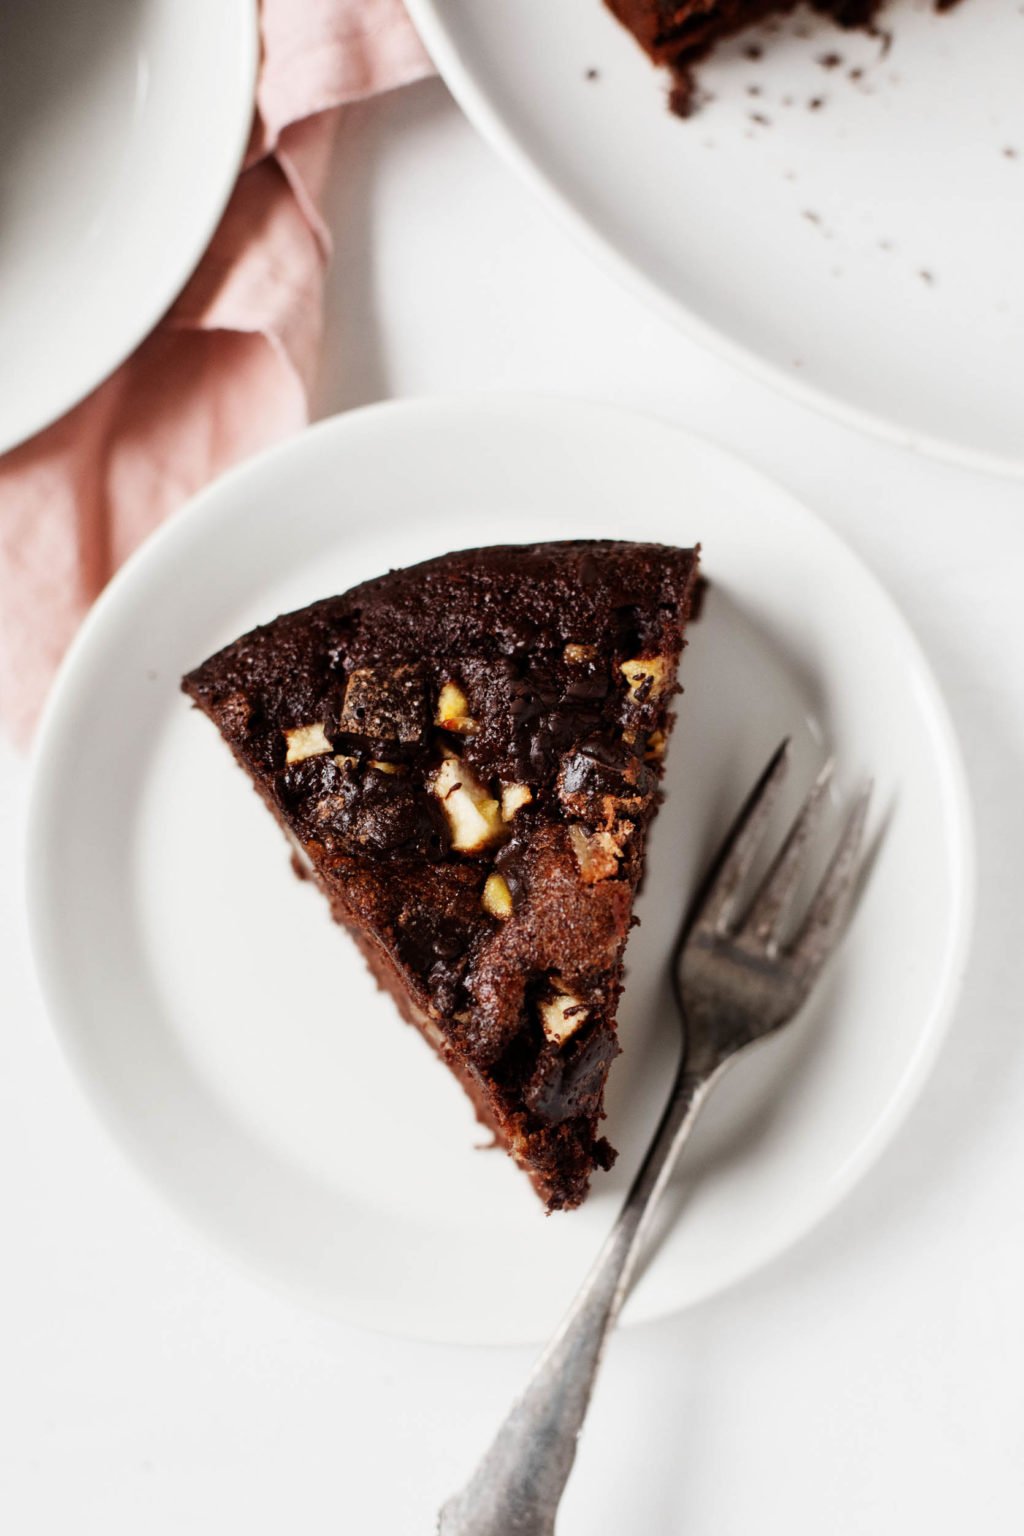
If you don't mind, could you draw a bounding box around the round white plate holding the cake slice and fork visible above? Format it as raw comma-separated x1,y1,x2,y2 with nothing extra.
29,398,972,1341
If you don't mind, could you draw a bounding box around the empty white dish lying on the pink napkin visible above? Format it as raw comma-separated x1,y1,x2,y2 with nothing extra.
0,0,259,452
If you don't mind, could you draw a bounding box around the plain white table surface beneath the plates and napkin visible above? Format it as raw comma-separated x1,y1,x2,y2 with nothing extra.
0,83,1024,1536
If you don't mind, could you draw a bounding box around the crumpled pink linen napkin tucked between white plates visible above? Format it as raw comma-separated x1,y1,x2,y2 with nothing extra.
0,0,431,742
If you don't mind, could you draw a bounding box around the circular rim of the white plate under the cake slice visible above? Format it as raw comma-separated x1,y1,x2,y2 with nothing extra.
23,392,976,1349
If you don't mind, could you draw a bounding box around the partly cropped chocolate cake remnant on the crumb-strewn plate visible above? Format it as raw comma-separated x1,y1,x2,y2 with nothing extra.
605,0,956,117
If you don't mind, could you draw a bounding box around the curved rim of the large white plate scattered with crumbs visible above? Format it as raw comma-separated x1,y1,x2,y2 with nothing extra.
405,0,1024,479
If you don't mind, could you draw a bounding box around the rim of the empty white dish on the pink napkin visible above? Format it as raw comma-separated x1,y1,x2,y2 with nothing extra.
0,0,259,455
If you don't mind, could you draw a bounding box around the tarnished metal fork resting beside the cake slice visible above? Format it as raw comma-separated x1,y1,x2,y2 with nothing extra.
438,742,870,1536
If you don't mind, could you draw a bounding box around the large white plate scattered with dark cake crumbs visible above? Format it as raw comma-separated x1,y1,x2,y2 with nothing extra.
408,0,1024,473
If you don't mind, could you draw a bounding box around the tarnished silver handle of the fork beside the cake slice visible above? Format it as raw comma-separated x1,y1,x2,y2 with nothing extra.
438,1063,717,1536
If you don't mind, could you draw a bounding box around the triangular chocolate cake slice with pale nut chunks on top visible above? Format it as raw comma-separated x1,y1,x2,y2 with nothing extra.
183,541,697,1209
